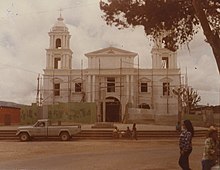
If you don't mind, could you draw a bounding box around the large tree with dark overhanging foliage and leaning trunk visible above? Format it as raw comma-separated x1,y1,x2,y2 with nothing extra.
100,0,220,72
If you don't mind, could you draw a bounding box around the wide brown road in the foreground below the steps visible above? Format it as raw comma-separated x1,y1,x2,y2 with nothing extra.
0,139,203,170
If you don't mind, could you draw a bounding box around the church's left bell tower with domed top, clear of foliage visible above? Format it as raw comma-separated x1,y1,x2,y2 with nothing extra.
46,14,73,70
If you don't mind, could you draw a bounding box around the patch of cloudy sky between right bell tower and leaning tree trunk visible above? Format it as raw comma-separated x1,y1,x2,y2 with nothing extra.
179,32,220,105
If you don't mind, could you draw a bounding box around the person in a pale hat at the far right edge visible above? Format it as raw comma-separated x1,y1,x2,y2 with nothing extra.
202,126,218,170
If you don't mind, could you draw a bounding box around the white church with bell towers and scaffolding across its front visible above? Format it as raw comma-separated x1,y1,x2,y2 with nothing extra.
43,17,181,122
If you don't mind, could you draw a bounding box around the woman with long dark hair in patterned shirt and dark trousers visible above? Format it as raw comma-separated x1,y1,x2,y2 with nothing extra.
179,120,194,170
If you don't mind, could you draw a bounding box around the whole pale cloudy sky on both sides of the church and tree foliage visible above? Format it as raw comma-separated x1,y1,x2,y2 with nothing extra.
0,0,220,105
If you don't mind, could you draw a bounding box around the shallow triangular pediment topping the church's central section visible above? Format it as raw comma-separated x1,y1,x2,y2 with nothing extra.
85,47,137,57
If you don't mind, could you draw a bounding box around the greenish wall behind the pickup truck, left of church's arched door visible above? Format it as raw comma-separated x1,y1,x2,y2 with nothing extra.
21,103,96,124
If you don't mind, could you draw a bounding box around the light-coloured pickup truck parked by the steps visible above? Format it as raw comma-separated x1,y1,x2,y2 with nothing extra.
16,119,81,142
